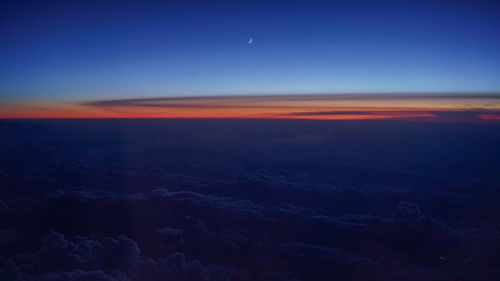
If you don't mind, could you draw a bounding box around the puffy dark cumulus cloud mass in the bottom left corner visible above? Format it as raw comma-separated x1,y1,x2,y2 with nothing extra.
0,232,248,281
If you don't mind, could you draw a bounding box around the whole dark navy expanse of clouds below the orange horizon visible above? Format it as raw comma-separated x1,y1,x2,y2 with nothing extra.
0,120,500,281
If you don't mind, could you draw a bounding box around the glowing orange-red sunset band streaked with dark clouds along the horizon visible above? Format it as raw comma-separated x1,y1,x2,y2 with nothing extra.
0,93,500,121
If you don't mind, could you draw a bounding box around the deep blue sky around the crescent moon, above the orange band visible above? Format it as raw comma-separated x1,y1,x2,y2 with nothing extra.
0,1,500,100
